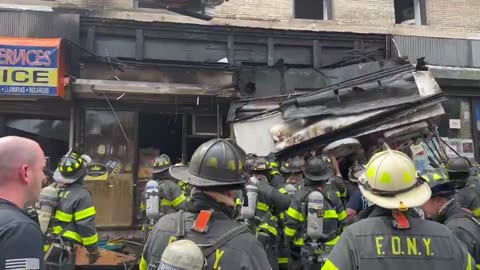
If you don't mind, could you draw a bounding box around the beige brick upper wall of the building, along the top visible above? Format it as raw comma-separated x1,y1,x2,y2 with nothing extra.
0,0,480,37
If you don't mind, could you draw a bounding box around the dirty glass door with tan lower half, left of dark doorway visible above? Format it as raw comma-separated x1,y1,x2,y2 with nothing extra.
84,110,137,226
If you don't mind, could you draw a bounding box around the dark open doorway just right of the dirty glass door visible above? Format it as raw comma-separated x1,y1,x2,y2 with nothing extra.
138,113,182,164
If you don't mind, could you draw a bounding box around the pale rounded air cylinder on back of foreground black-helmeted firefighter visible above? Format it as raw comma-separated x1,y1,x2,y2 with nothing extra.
158,240,206,270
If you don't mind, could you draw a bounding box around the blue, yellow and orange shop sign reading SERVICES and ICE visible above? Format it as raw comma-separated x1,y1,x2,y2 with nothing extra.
0,37,65,97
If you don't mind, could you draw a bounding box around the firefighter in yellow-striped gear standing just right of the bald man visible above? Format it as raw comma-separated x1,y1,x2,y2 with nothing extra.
44,150,100,269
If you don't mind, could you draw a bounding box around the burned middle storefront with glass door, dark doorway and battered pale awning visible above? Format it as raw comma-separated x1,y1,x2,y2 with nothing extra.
73,79,235,230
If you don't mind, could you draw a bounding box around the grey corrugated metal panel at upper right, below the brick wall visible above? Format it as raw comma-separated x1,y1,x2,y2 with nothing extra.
394,36,472,67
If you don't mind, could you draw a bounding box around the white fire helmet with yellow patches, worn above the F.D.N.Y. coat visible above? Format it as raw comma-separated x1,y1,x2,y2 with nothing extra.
359,148,432,211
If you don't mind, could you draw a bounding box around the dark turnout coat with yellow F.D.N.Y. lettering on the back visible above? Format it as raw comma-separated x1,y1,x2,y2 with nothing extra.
322,207,475,270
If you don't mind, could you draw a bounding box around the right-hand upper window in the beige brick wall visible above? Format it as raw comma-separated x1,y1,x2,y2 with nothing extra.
394,0,427,25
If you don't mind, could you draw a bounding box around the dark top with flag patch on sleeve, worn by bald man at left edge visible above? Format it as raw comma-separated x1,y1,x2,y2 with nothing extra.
0,199,45,270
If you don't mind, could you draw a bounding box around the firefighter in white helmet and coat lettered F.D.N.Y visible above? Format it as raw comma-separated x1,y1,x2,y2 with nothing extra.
322,149,475,270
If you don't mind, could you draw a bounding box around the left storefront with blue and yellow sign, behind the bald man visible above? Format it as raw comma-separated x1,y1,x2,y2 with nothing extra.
0,38,71,169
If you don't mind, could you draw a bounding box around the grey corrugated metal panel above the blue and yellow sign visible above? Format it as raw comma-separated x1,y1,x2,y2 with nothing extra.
0,11,80,44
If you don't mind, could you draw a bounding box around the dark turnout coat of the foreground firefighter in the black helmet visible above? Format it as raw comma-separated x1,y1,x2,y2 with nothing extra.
140,193,271,270
